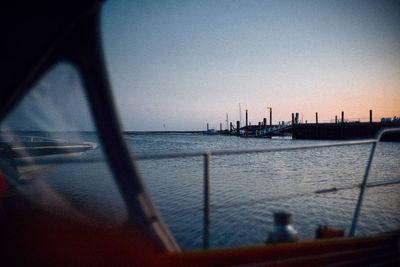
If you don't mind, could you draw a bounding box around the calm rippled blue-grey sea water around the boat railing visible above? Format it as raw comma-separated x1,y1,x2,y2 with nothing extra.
41,134,400,250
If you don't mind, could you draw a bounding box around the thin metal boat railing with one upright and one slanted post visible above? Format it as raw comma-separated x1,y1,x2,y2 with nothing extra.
135,128,400,249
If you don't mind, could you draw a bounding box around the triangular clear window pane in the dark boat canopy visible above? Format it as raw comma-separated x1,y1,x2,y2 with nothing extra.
0,63,126,223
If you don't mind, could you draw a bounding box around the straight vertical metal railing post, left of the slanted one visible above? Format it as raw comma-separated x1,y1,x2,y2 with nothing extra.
203,152,211,249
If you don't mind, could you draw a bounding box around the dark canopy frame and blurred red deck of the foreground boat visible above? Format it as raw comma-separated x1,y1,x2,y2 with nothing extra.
0,1,400,266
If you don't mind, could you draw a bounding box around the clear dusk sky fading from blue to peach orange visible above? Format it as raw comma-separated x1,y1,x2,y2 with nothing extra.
101,0,400,130
